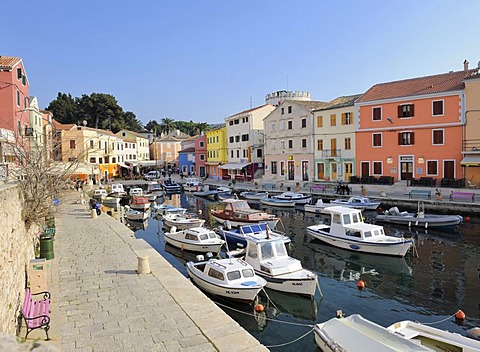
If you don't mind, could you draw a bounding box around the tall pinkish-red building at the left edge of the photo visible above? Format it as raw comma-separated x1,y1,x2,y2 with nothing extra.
0,56,30,162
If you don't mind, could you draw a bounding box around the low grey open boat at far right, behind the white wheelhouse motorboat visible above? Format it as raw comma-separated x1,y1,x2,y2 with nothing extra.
375,202,463,230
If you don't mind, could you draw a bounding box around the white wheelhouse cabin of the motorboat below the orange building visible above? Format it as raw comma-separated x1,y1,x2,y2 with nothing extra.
324,206,385,240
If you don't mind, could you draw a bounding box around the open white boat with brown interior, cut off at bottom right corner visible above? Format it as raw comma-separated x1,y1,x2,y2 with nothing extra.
387,320,480,352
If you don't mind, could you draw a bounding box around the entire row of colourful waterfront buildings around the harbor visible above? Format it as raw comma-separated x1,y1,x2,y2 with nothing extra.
0,56,480,185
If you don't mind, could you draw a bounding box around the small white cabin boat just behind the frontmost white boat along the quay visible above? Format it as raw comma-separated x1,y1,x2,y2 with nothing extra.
164,226,225,253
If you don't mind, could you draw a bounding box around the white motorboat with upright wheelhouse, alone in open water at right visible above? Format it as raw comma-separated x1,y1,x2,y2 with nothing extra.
307,206,413,257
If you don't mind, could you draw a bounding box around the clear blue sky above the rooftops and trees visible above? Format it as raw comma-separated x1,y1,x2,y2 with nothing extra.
0,0,480,123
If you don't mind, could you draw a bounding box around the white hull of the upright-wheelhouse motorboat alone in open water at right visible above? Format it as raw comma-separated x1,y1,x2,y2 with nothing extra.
307,225,413,257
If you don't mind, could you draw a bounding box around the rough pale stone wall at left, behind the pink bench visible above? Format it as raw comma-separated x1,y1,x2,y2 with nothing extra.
0,185,38,334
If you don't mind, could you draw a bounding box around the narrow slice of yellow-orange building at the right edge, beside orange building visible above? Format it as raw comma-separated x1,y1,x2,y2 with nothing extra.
460,66,480,187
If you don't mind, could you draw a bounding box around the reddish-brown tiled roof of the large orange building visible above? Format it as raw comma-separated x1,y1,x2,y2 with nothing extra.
358,69,477,103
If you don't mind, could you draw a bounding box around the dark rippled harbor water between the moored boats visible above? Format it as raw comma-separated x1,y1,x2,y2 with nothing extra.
126,194,480,351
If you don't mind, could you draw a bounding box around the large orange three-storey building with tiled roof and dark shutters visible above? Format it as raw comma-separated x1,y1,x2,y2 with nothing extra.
355,67,477,183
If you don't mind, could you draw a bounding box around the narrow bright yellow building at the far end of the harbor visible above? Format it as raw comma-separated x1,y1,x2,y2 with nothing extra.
205,126,228,179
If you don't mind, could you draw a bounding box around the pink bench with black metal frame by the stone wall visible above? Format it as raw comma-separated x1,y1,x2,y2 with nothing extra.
20,288,50,341
